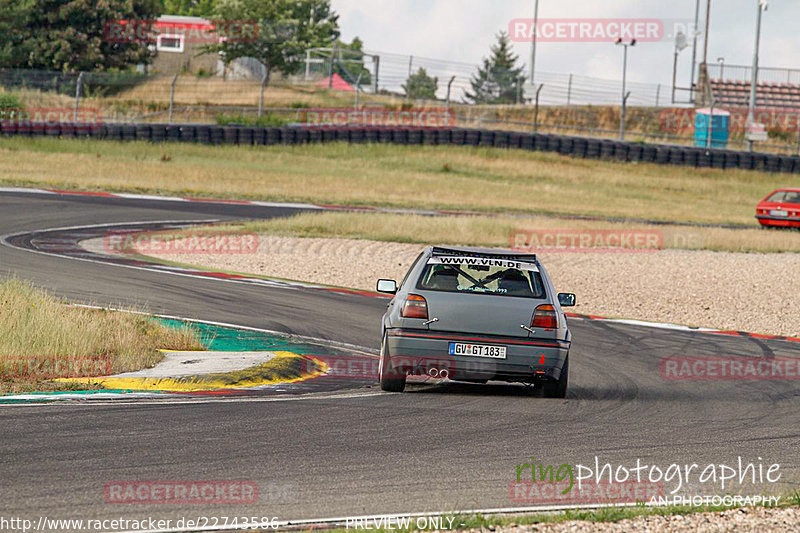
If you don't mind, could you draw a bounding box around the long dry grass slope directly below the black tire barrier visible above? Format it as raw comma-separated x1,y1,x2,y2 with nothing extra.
0,138,798,227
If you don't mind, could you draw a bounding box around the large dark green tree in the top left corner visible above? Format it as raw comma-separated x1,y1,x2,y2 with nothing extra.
0,0,161,72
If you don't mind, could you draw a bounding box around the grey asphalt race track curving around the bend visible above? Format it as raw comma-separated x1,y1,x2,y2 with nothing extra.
0,193,800,520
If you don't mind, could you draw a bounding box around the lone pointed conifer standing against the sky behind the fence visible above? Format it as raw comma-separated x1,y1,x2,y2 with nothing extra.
465,32,525,104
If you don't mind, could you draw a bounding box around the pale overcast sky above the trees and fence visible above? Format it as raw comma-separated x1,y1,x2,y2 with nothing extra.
332,0,800,85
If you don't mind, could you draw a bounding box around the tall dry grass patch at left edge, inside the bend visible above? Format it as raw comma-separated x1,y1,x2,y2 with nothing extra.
0,278,203,393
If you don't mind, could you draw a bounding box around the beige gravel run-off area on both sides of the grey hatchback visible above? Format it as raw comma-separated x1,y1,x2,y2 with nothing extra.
131,235,800,336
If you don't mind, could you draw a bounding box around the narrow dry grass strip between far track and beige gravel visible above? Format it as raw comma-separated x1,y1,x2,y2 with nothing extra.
144,212,800,253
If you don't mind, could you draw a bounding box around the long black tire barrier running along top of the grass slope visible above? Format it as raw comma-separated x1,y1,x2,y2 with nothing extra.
0,121,800,173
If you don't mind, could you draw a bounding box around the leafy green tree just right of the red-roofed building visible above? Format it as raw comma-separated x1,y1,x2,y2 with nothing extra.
209,0,339,83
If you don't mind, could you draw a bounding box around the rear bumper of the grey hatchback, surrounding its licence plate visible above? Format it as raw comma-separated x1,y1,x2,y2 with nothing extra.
386,328,570,383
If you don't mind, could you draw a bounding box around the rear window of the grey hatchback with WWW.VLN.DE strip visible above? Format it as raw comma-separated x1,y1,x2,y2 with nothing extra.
417,255,545,298
